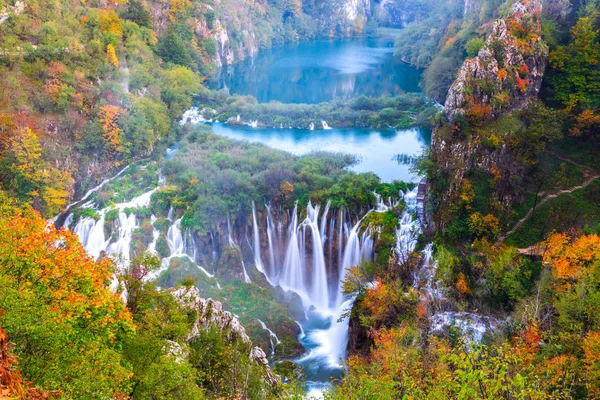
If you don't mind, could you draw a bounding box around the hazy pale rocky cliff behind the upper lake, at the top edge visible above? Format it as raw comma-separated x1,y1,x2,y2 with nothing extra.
146,0,371,67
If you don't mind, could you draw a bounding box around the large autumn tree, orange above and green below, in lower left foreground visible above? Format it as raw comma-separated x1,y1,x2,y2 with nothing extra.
0,206,133,399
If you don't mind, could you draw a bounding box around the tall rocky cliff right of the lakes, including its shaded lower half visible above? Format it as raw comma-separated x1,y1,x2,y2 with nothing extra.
430,0,548,231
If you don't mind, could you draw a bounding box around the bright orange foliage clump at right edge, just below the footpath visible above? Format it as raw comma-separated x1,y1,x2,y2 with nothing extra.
544,233,600,280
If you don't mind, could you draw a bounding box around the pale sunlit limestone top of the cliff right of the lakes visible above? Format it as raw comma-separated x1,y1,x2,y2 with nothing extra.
445,0,548,119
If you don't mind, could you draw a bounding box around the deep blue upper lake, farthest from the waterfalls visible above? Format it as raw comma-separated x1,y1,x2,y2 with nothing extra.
208,37,421,103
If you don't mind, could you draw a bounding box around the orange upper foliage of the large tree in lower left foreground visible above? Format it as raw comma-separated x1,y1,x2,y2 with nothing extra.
0,211,133,343
